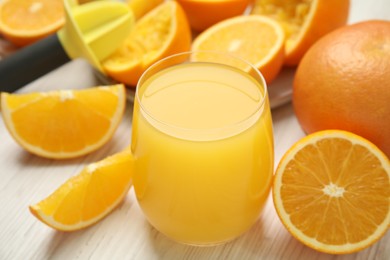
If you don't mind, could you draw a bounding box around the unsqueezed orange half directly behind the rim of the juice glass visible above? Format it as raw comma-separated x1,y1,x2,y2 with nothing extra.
192,15,285,83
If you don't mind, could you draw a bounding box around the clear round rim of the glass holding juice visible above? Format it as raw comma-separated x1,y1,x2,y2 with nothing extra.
135,51,268,136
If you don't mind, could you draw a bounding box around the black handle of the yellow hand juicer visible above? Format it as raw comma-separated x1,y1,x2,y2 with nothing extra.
0,34,69,92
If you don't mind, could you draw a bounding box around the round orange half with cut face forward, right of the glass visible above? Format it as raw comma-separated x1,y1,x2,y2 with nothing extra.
273,130,390,254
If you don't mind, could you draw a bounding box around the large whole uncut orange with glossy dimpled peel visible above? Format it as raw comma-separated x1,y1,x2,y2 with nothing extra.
293,20,390,157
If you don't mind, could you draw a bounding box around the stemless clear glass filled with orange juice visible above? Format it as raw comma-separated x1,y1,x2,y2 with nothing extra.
131,52,274,245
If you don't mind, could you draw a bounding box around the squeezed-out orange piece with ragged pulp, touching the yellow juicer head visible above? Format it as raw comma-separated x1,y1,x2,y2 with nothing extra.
103,1,191,87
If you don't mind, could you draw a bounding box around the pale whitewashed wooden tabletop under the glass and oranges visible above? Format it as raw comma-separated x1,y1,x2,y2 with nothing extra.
0,0,390,260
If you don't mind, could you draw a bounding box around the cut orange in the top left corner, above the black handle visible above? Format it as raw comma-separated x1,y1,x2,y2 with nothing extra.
0,0,65,46
